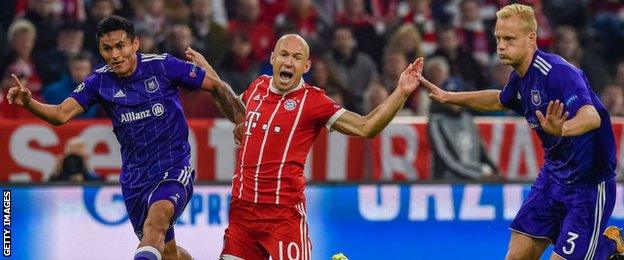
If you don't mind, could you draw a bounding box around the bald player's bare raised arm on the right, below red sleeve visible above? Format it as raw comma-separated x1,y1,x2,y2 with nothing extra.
332,58,423,138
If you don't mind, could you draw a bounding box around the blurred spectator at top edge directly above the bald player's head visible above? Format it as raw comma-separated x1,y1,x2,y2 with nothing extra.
275,0,327,49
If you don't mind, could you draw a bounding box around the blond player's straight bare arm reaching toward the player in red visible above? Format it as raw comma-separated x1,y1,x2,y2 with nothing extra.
420,77,505,111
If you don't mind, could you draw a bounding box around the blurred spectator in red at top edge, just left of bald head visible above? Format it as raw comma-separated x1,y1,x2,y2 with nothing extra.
228,0,275,60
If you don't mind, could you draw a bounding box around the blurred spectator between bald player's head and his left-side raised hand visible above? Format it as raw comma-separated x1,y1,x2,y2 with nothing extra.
219,33,260,95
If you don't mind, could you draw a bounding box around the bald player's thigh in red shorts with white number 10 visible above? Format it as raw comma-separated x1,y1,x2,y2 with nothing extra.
260,203,312,260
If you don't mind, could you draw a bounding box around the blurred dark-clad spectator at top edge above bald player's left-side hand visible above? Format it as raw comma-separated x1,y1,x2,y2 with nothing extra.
189,0,228,64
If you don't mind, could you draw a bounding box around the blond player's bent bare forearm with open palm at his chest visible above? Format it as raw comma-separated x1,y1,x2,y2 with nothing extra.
535,100,601,136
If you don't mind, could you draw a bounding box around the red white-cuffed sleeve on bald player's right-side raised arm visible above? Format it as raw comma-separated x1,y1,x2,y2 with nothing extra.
310,91,347,131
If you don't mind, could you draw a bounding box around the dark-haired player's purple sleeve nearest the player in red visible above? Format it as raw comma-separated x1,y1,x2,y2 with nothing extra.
164,54,206,90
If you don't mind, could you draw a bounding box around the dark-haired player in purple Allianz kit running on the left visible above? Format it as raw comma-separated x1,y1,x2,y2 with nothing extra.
7,16,245,260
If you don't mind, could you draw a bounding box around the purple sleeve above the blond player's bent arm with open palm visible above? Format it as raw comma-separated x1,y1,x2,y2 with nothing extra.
547,65,593,118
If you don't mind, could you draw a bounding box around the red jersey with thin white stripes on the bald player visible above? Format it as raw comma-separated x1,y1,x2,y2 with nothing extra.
232,75,346,205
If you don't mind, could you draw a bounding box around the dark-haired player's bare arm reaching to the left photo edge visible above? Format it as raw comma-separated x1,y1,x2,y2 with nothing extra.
7,74,84,126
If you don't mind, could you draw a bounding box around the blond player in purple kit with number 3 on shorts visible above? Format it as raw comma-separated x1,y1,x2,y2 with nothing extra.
421,4,624,259
